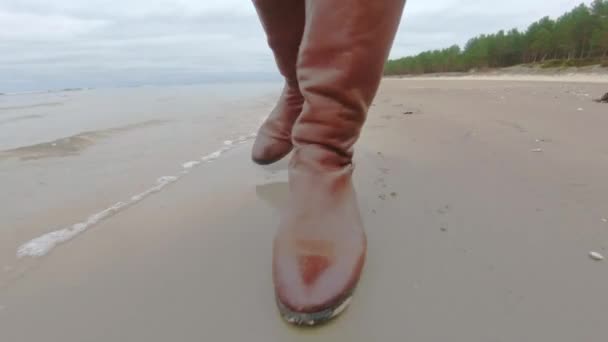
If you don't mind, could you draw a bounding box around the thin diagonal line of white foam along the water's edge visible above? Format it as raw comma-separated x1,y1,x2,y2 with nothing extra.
17,133,256,258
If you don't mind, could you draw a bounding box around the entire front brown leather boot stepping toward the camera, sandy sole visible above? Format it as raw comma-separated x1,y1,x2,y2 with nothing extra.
273,0,405,325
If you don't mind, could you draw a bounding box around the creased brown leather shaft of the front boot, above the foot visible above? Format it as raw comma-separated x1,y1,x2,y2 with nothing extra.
293,0,405,158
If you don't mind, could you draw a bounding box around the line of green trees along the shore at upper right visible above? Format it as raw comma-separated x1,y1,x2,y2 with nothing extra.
385,0,608,75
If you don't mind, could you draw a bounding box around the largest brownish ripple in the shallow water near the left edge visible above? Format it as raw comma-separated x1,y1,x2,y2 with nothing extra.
0,120,169,160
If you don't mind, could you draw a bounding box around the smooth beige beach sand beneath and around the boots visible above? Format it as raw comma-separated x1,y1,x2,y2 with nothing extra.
0,79,608,342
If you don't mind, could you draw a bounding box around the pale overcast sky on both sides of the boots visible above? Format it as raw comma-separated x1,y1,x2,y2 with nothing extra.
0,0,590,92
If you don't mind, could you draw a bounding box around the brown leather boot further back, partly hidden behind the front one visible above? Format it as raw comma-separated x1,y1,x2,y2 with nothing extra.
251,0,304,165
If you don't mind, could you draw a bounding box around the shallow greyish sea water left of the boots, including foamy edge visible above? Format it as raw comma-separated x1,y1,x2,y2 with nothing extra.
0,82,281,264
